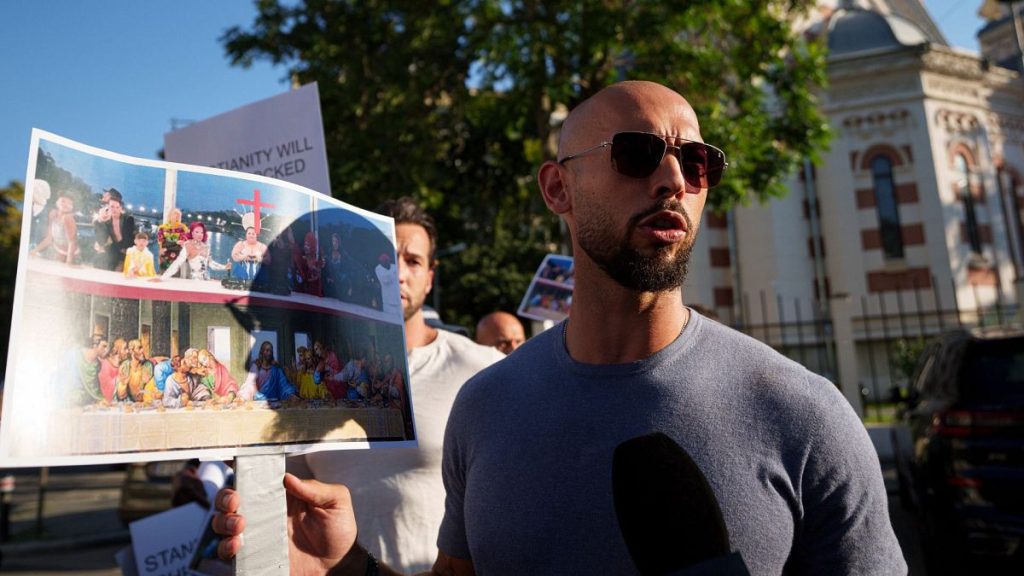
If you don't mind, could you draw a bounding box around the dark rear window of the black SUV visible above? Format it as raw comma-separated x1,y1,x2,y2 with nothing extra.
961,338,1024,406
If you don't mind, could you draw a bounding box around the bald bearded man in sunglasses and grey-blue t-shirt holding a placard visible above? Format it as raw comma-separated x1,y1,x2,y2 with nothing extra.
215,82,907,575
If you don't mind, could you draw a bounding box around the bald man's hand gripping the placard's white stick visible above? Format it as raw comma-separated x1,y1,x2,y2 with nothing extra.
213,474,367,574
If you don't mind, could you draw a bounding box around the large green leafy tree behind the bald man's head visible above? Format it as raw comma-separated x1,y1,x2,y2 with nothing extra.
222,0,827,325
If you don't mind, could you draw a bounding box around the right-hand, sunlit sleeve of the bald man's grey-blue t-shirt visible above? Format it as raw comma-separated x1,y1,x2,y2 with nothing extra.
788,375,907,575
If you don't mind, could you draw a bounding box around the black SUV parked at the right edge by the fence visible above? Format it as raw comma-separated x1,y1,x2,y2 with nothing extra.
893,328,1024,574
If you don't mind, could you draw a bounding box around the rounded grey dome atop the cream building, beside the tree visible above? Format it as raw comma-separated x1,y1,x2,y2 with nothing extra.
827,7,928,57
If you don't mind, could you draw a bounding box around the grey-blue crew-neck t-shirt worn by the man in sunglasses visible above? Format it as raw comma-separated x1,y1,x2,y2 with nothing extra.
437,313,906,575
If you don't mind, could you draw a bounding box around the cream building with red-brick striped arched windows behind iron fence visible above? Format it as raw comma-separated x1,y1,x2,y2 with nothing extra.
685,0,1024,409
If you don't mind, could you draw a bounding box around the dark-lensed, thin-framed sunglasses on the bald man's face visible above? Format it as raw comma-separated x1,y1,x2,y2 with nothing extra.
558,132,729,189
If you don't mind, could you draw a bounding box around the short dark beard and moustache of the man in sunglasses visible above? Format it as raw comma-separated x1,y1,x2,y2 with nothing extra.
577,200,696,292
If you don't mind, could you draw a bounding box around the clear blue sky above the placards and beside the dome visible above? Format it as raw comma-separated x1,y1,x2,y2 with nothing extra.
0,0,981,186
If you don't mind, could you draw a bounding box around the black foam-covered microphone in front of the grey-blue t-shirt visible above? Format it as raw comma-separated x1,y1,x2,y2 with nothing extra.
611,433,750,576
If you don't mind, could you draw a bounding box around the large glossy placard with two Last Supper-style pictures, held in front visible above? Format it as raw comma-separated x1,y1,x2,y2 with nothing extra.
0,130,415,466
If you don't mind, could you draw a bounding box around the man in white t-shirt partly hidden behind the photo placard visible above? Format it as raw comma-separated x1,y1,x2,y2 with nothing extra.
289,198,504,572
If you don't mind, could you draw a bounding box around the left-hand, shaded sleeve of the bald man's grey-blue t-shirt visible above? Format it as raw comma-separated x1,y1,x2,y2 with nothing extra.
437,389,471,560
